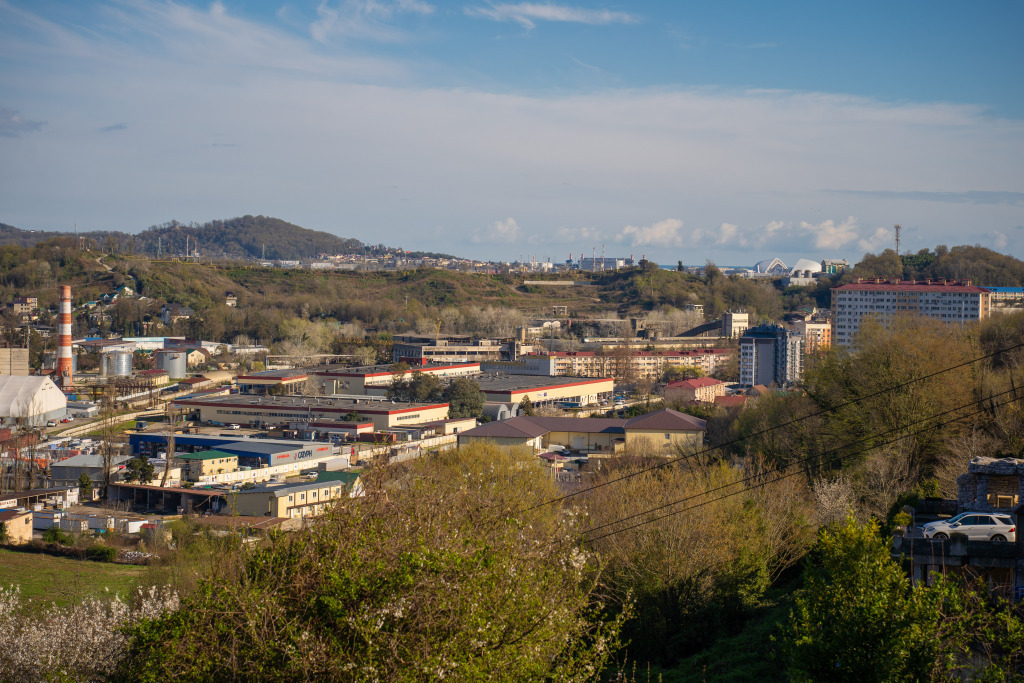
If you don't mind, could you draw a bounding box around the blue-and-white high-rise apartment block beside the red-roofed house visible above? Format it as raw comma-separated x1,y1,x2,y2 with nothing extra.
739,325,804,386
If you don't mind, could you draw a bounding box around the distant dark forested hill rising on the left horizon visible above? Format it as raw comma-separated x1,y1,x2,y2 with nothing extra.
0,216,362,260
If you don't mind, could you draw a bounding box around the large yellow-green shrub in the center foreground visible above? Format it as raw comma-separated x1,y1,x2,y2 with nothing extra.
117,446,622,681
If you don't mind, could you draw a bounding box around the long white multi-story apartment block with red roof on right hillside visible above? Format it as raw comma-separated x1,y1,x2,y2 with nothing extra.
831,279,992,345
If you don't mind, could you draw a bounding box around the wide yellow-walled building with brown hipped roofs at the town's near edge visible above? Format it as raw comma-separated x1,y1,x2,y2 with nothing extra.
459,409,705,454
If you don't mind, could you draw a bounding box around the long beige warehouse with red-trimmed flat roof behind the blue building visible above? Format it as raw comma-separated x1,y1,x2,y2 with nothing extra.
171,394,449,431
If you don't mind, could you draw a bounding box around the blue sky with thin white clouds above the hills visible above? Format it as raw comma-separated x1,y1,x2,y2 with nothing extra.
0,0,1024,265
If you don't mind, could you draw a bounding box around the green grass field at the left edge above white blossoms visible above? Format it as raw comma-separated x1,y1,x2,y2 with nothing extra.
0,550,145,607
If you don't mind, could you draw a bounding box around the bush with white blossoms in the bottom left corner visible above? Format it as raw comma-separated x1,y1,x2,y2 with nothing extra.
0,586,178,683
